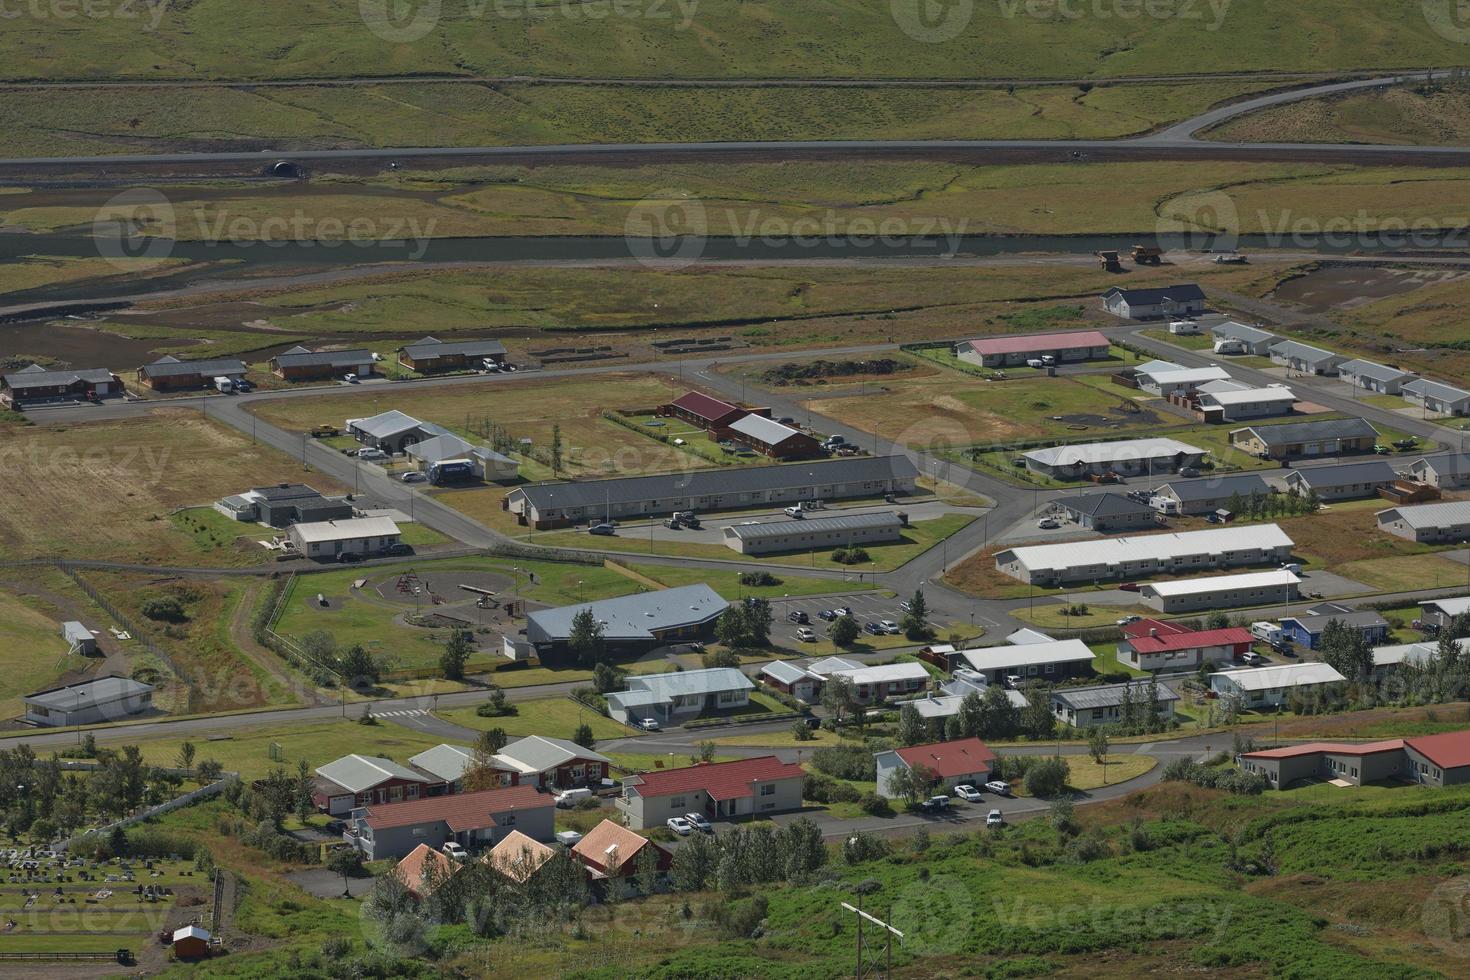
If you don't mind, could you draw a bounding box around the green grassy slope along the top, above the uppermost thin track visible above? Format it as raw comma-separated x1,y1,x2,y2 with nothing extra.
0,0,1466,79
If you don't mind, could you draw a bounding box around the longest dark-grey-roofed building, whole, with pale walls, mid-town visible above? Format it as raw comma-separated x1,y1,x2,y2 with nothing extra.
506,455,919,529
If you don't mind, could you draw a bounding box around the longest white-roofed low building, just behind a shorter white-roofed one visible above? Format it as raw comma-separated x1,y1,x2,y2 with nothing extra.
995,525,1294,585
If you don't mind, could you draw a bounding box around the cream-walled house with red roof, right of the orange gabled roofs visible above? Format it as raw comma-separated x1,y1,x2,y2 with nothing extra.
617,755,806,827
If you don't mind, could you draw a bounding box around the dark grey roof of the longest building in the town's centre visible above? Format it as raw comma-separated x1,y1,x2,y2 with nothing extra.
512,455,919,510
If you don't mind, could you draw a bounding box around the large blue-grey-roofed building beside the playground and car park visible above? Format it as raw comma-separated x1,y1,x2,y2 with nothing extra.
526,583,729,661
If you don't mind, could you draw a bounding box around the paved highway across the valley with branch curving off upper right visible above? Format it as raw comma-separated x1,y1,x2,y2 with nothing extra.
0,72,1446,168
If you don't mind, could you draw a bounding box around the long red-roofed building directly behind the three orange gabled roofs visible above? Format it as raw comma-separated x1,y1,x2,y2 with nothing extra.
343,786,556,861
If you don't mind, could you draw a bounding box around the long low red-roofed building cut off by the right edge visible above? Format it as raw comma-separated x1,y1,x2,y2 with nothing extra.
1241,732,1470,789
